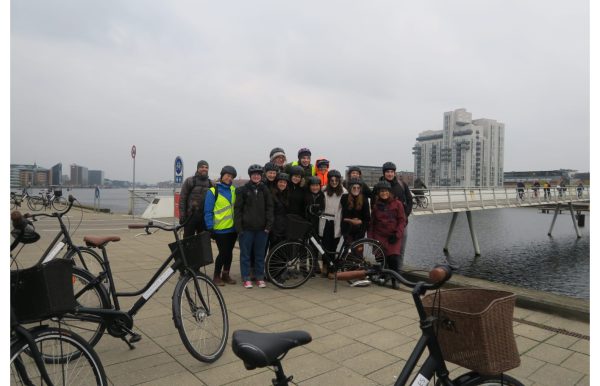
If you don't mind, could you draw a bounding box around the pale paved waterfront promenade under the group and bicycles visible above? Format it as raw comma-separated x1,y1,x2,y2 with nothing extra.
19,210,590,386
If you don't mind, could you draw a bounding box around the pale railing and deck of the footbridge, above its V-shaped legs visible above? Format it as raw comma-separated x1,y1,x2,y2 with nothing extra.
411,185,590,214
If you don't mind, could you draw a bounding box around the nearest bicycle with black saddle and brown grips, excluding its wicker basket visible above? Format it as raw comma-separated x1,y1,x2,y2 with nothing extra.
231,265,523,386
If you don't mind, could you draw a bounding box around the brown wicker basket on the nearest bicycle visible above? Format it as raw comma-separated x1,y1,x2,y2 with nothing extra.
423,288,521,374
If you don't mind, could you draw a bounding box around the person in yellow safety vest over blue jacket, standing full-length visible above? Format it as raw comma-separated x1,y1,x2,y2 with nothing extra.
204,165,237,286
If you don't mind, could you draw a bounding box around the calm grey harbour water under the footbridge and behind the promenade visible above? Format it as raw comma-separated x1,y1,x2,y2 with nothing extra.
65,189,590,299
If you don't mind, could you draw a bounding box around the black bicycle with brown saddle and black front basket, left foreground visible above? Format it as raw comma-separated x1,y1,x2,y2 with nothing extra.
63,221,229,363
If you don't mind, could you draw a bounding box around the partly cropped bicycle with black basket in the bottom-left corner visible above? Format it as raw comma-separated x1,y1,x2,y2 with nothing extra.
10,229,107,386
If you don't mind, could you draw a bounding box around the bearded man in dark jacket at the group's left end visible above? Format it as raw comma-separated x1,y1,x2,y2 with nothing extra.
179,160,213,238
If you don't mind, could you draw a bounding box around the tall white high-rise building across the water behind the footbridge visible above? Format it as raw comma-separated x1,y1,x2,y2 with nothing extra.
413,109,504,187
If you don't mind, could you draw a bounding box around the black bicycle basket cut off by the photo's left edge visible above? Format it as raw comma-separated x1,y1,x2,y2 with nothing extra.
10,259,77,323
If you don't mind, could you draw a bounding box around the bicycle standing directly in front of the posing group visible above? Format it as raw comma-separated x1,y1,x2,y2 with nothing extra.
265,205,385,292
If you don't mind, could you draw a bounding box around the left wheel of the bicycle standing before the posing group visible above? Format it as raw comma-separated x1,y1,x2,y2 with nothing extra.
265,241,314,289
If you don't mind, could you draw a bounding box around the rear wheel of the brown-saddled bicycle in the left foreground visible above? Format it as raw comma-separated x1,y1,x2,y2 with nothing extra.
40,267,111,355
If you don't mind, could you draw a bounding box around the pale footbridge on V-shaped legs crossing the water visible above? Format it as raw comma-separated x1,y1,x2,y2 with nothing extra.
412,186,590,256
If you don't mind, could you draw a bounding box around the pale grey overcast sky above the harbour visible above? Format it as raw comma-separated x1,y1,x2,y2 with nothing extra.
10,0,590,182
